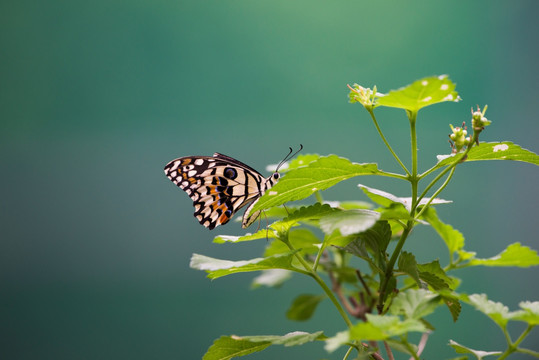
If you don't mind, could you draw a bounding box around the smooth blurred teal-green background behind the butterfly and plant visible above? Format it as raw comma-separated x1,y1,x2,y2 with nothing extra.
0,0,539,359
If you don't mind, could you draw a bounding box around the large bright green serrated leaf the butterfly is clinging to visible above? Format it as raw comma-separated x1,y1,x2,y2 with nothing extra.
251,155,378,213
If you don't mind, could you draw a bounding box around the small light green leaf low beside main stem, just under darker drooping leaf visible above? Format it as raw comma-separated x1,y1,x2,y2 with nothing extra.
390,288,439,320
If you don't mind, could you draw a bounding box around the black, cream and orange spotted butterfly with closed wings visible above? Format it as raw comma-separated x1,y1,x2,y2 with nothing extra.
165,145,303,230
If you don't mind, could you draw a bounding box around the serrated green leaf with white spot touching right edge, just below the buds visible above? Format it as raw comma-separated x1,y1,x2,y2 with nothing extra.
436,141,539,168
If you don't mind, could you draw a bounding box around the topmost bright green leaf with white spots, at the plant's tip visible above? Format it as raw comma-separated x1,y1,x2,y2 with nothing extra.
376,75,460,112
